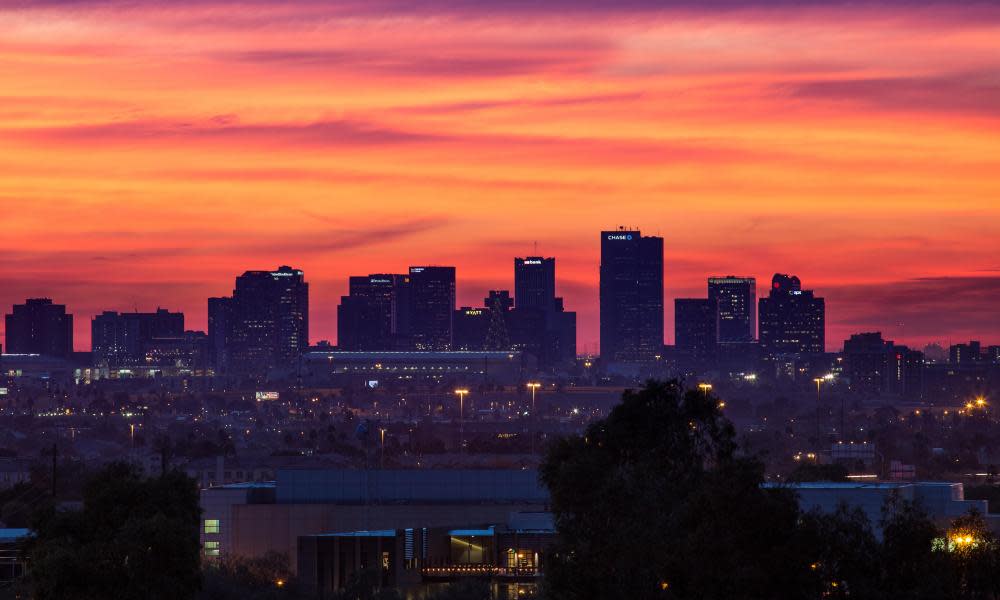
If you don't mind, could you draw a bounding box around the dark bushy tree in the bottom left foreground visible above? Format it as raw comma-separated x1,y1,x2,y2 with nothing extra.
26,464,201,600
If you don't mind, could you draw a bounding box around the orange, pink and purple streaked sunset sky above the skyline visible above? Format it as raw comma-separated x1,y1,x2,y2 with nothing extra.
0,0,1000,352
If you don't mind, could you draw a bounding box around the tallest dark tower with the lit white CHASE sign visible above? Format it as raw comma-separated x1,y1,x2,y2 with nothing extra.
600,229,663,363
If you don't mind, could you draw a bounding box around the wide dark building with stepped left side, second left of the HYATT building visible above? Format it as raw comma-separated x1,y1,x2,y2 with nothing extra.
337,274,410,351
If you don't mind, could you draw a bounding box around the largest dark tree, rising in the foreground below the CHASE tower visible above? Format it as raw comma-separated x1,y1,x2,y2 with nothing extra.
541,382,821,600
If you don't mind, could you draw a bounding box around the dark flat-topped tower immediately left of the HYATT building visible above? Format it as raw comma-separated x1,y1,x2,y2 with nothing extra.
410,267,455,350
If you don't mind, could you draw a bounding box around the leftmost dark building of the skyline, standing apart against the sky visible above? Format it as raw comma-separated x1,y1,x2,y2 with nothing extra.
5,298,73,358
